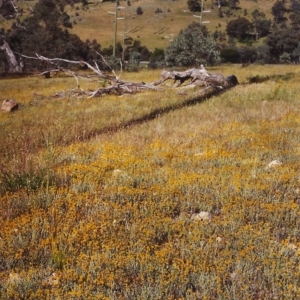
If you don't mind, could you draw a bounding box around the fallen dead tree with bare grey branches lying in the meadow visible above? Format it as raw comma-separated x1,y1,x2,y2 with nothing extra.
19,53,238,98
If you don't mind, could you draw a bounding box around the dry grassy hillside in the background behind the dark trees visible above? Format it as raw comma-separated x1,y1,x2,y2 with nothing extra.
0,0,275,51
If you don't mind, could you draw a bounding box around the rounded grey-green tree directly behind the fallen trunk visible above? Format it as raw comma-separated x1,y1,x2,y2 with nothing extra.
165,22,220,66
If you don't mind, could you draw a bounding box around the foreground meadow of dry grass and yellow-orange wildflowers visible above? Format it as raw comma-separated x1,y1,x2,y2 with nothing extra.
0,65,300,300
